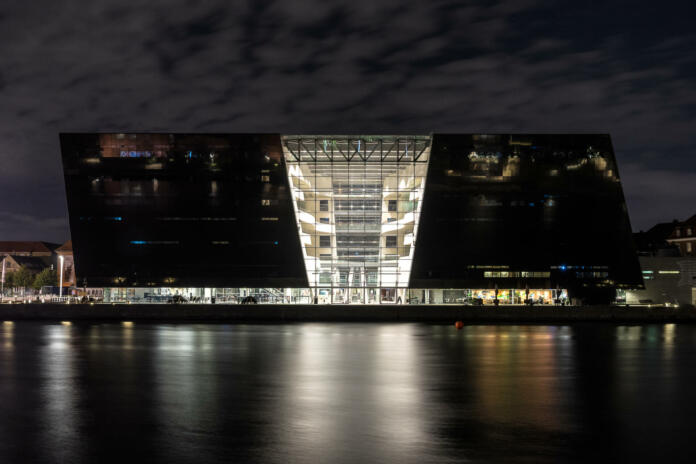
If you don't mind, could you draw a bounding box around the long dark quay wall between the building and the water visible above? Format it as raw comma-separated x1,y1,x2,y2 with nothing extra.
0,303,696,324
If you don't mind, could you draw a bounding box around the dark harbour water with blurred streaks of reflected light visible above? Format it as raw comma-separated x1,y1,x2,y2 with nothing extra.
0,322,696,463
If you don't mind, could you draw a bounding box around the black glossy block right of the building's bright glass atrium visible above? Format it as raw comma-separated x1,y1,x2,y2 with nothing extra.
410,134,642,302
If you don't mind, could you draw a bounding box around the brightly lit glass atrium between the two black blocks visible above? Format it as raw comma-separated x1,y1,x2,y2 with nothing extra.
282,135,431,304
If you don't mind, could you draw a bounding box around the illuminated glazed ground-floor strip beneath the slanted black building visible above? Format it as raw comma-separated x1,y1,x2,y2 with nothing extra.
104,287,570,305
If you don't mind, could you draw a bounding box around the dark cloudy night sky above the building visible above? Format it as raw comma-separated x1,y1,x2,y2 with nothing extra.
0,0,696,242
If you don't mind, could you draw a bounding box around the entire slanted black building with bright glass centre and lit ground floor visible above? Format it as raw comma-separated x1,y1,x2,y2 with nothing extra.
61,133,643,304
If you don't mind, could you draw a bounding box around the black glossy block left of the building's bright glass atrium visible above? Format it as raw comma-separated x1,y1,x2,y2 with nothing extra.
61,134,307,288
